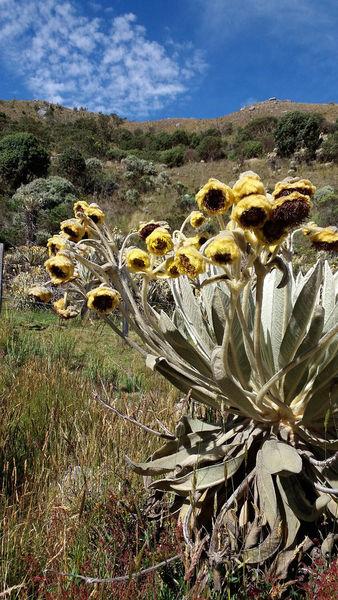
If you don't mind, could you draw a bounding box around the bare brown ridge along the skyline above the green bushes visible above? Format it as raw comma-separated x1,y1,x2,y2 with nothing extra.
0,98,338,132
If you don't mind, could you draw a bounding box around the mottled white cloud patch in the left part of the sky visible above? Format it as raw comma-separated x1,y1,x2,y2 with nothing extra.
0,0,205,116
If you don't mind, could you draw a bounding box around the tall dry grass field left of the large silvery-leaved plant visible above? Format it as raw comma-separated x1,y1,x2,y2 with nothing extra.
0,311,182,600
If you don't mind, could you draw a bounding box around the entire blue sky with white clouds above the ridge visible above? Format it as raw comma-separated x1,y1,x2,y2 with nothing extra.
0,0,338,120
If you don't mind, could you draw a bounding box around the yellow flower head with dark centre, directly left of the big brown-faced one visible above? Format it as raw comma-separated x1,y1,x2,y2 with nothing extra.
231,194,271,229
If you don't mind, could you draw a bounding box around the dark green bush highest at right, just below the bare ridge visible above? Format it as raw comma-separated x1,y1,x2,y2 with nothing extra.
275,110,324,157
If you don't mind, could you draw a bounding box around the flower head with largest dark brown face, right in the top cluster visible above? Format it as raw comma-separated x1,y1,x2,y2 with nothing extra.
271,191,312,228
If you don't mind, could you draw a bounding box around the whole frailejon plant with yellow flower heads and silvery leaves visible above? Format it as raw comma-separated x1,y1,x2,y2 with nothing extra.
29,172,338,579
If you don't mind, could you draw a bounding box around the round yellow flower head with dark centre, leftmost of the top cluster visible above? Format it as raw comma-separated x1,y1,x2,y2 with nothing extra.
196,179,235,215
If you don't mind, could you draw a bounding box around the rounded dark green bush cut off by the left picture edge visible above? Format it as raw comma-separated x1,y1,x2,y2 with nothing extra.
0,133,49,189
